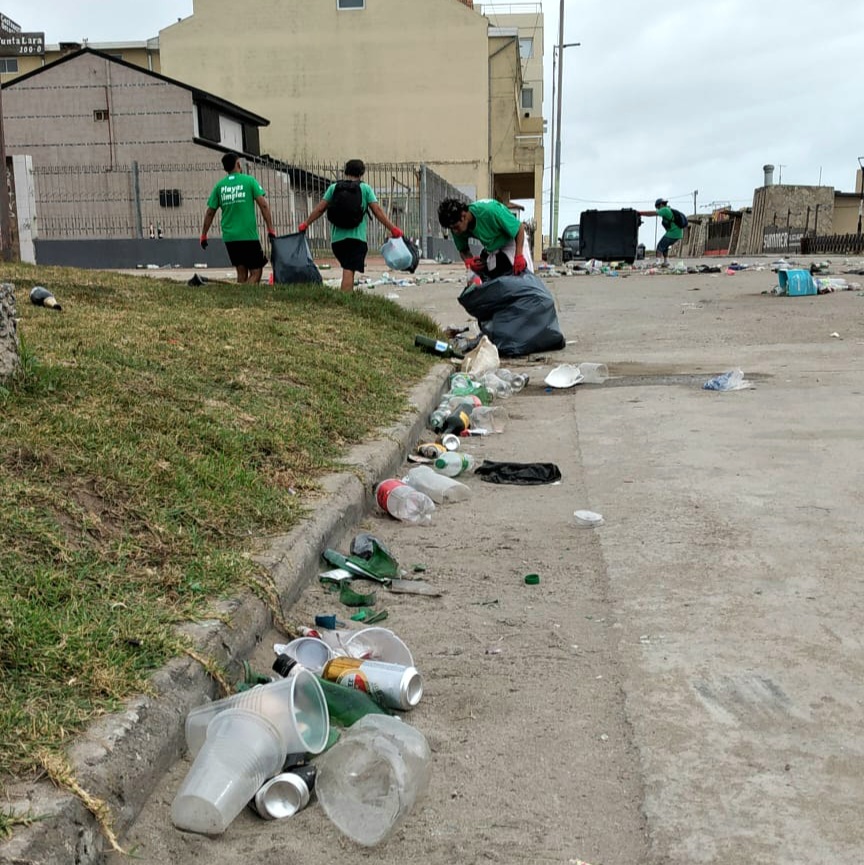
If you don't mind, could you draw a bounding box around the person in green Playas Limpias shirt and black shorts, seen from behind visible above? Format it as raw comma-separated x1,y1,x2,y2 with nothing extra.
201,153,276,285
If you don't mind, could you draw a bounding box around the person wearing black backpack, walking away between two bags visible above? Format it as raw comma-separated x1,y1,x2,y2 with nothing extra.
298,159,402,292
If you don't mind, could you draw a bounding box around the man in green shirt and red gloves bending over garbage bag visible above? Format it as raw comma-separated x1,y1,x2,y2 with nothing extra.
438,198,534,280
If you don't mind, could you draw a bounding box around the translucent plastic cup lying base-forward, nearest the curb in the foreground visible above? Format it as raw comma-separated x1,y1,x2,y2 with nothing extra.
171,709,286,835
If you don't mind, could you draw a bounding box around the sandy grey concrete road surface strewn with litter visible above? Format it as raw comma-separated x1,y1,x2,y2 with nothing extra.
109,260,864,865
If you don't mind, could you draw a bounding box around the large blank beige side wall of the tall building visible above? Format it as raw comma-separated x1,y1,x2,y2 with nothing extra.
159,0,489,197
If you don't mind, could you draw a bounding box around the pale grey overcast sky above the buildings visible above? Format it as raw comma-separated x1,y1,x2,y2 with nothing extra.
6,0,864,245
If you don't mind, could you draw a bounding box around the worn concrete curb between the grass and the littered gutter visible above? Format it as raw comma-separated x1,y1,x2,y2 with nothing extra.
0,365,452,865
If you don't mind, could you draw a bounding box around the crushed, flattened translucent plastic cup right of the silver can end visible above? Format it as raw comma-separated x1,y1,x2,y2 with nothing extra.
315,715,432,847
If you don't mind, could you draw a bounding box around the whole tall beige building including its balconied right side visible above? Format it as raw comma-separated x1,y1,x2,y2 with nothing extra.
159,0,543,252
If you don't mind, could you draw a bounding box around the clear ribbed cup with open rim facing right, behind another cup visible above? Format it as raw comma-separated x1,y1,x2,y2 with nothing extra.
186,669,330,756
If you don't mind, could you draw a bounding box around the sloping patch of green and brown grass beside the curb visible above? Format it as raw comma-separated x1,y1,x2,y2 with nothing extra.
0,265,437,788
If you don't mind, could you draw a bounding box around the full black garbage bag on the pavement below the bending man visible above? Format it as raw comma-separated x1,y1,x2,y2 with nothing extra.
459,271,565,357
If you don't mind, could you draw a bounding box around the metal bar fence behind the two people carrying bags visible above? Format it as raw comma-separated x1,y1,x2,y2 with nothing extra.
33,159,465,254
